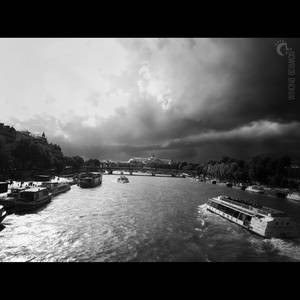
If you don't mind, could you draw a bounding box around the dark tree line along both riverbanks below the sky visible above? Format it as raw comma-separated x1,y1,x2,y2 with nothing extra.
0,123,300,188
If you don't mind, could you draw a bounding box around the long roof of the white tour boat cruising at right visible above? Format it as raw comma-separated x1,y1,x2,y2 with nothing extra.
211,195,285,217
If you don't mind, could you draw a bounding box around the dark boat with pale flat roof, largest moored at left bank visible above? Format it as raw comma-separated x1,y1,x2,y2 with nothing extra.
15,187,51,212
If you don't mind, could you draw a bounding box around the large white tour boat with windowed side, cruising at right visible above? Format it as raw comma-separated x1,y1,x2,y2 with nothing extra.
207,195,297,238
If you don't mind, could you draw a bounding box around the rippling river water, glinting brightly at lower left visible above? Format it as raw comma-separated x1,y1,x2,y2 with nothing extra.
0,175,300,262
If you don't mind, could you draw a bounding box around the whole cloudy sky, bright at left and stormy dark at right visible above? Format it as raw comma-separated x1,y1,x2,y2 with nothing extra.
0,38,300,162
